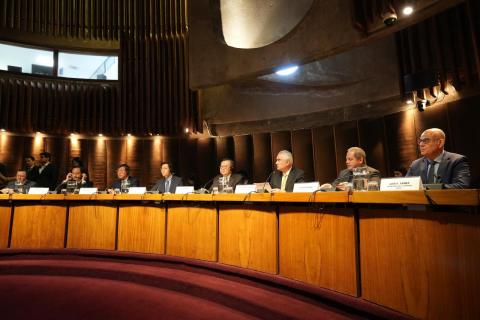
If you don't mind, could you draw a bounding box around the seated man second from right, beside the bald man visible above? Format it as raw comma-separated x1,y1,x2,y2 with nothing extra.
320,147,380,191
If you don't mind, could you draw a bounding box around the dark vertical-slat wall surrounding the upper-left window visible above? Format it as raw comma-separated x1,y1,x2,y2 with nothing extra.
0,0,201,135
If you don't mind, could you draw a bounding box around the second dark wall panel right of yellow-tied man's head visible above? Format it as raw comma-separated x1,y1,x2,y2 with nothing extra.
312,126,337,183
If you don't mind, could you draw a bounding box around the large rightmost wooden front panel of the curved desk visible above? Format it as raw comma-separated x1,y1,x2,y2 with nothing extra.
360,209,480,319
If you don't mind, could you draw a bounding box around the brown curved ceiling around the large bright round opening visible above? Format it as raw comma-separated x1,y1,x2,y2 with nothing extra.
189,0,462,135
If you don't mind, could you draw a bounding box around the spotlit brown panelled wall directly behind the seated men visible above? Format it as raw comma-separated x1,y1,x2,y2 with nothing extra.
0,96,480,188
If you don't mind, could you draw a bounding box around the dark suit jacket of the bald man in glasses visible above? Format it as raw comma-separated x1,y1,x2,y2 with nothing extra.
406,151,470,189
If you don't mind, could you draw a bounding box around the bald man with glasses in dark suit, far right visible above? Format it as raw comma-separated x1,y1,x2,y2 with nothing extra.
407,128,470,189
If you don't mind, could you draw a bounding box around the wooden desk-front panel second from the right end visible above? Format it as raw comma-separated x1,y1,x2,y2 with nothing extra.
279,207,359,296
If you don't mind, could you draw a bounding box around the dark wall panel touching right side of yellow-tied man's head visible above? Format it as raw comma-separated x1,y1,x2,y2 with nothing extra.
292,129,315,181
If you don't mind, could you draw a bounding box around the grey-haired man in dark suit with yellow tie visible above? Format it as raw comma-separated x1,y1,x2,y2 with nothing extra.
269,150,305,192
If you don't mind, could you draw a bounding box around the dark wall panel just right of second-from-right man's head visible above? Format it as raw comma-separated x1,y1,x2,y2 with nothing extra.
358,118,389,176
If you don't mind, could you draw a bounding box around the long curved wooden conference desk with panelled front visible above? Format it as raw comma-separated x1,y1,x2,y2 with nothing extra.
0,190,480,319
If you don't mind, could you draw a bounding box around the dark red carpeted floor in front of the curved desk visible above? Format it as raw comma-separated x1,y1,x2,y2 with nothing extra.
0,250,412,319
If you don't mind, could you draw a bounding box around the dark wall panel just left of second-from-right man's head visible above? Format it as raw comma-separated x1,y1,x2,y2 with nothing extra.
333,121,359,172
